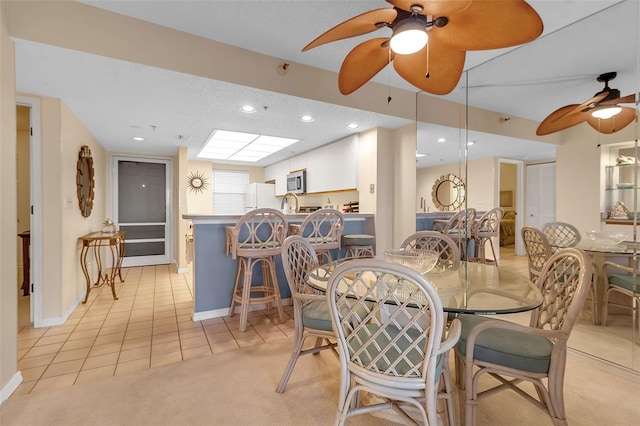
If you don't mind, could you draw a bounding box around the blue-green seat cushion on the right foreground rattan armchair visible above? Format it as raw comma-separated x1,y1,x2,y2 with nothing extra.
456,315,553,373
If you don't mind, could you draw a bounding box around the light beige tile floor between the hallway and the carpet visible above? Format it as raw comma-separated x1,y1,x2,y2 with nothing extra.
14,265,294,395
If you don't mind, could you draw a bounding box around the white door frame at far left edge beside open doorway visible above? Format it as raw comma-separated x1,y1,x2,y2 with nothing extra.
16,95,43,328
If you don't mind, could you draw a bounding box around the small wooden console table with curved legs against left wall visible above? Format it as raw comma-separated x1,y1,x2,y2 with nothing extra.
78,231,126,303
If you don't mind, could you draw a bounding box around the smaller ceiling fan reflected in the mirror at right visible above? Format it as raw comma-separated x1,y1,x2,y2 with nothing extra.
536,72,636,136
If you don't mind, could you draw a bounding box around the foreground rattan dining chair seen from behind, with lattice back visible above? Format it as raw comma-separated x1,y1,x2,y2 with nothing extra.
327,259,460,425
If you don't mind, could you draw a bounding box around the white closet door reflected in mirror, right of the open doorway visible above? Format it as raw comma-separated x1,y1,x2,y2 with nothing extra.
525,163,556,229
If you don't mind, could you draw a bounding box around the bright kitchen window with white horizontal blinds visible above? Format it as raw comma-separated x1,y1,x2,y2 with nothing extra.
211,169,249,214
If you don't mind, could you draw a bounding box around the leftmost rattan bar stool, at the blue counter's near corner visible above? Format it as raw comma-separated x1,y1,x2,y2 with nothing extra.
227,208,287,331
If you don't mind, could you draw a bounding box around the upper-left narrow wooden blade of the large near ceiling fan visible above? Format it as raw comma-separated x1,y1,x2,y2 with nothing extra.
302,8,398,52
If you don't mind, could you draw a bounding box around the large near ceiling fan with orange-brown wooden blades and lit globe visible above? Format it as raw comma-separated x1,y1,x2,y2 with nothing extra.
302,0,543,95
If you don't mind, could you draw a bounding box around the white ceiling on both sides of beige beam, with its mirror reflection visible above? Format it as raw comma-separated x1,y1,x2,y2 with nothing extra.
16,0,640,167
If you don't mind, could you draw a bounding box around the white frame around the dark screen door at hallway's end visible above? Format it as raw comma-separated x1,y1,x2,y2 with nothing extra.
110,154,174,267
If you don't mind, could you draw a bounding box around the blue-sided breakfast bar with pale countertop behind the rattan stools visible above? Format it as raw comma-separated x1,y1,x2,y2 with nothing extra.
182,213,375,321
